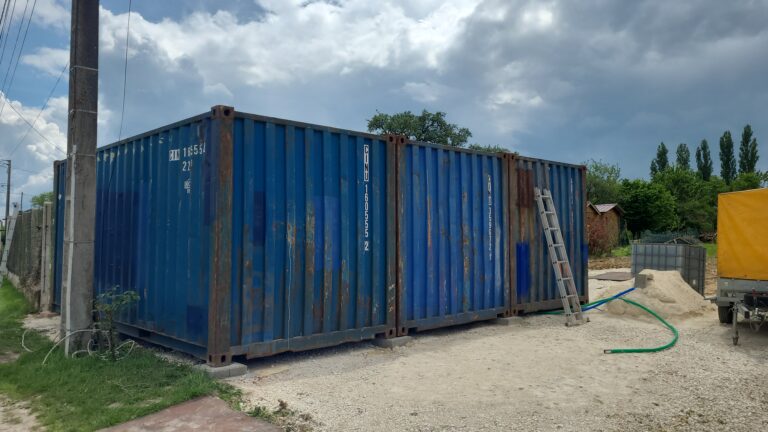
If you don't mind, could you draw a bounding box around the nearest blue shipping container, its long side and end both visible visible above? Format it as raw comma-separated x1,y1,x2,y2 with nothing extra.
55,107,396,364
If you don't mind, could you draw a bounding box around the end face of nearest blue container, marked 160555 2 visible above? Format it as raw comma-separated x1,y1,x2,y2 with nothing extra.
231,113,395,357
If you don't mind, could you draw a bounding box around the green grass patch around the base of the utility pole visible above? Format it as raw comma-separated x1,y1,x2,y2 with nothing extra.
0,280,234,431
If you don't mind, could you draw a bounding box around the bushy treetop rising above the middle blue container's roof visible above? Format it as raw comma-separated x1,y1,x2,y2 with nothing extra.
368,110,472,147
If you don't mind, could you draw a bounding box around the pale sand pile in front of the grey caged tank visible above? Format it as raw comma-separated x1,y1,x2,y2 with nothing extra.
601,270,713,318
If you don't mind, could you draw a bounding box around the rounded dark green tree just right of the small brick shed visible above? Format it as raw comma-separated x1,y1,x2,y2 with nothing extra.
619,180,678,236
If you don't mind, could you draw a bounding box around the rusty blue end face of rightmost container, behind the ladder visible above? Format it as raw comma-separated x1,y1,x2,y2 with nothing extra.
508,156,588,313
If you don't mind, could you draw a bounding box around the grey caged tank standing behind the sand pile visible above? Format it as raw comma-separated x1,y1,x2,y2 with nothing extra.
632,243,707,295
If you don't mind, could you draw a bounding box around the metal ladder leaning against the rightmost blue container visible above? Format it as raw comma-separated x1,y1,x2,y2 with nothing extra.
534,188,589,326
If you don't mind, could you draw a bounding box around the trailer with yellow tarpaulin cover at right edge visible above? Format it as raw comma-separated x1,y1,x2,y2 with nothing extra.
715,188,768,345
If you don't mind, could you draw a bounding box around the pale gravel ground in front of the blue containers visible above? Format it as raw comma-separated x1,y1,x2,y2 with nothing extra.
229,281,768,431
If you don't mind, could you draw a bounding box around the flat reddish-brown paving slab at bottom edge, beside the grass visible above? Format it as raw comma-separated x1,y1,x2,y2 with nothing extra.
97,397,283,432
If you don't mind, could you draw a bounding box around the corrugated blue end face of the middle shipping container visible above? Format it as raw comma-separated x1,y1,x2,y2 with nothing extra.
398,142,509,335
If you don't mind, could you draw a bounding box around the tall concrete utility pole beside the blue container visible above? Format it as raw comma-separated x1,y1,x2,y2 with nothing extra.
61,0,99,355
